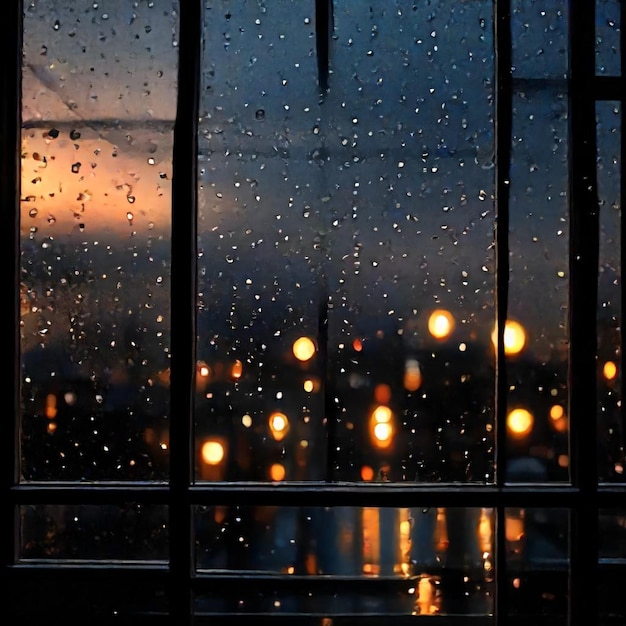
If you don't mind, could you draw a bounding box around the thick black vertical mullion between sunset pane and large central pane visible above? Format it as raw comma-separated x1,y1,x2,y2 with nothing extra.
169,0,202,626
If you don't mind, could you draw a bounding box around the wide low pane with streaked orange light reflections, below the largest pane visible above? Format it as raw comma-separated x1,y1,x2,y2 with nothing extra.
195,506,494,614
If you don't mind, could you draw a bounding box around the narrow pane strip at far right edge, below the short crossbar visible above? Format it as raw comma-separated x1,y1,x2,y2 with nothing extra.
596,102,626,482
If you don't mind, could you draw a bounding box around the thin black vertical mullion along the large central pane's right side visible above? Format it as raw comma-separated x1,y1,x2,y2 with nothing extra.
494,0,513,626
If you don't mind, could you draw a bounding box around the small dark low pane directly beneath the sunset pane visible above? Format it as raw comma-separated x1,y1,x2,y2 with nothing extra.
20,504,168,563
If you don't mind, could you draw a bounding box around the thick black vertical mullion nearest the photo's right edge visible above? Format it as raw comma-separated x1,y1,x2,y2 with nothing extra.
569,0,599,625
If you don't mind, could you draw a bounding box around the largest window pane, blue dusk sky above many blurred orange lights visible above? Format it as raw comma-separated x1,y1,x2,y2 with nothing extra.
195,0,495,482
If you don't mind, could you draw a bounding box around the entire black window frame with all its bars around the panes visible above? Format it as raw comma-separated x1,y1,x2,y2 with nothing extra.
0,0,626,626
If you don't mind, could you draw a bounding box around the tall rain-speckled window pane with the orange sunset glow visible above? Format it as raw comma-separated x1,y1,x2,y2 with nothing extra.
21,0,177,480
